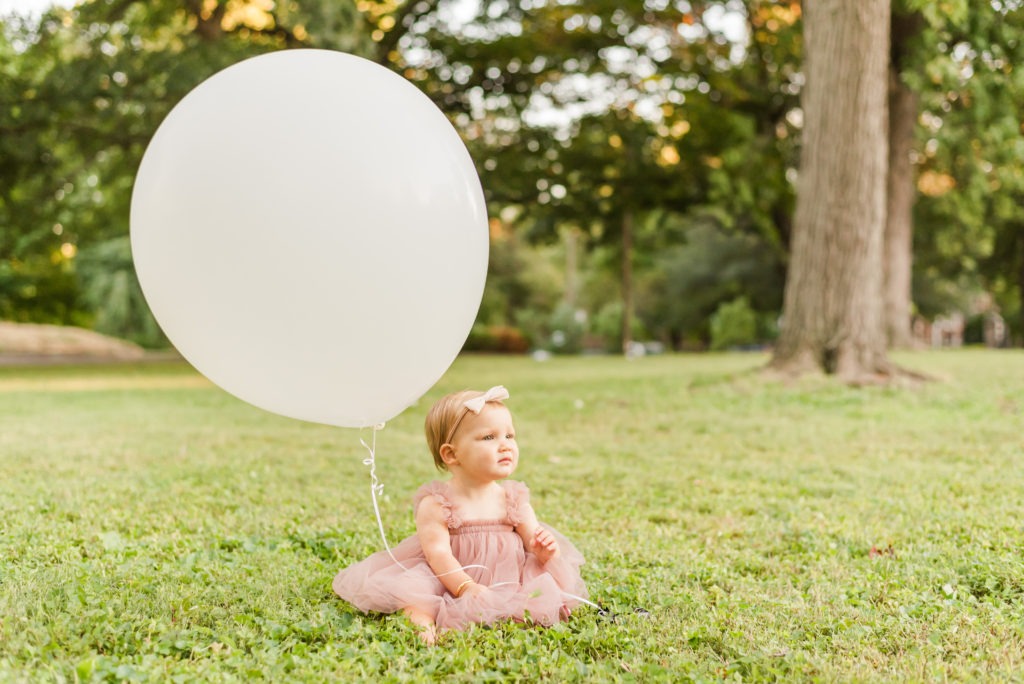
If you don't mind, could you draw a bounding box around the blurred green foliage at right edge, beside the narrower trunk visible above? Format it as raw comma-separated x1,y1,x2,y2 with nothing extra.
903,2,1024,344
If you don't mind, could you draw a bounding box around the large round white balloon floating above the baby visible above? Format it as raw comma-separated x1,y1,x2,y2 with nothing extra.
131,50,487,427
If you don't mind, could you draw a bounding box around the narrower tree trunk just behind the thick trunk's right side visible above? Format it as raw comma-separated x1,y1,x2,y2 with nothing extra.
884,13,922,348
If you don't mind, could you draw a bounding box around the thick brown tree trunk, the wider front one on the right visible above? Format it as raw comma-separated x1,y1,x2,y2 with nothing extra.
772,0,892,383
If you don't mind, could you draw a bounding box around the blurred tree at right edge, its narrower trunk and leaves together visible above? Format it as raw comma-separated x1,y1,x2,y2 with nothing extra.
885,0,1024,346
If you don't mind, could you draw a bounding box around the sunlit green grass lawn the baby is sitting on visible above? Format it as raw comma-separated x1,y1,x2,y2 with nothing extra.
0,350,1024,682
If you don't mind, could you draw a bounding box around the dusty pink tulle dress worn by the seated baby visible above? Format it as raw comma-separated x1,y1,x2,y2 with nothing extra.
333,480,587,630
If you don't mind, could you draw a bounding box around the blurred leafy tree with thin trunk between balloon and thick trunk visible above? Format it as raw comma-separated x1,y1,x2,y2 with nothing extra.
371,0,801,352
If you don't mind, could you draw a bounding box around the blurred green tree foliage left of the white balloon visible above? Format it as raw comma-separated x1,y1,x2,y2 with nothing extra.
0,0,373,339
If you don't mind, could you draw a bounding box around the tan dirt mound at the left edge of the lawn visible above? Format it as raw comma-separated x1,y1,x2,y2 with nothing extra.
0,320,146,362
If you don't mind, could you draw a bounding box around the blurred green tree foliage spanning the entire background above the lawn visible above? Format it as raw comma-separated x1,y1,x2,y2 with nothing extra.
0,0,1024,347
